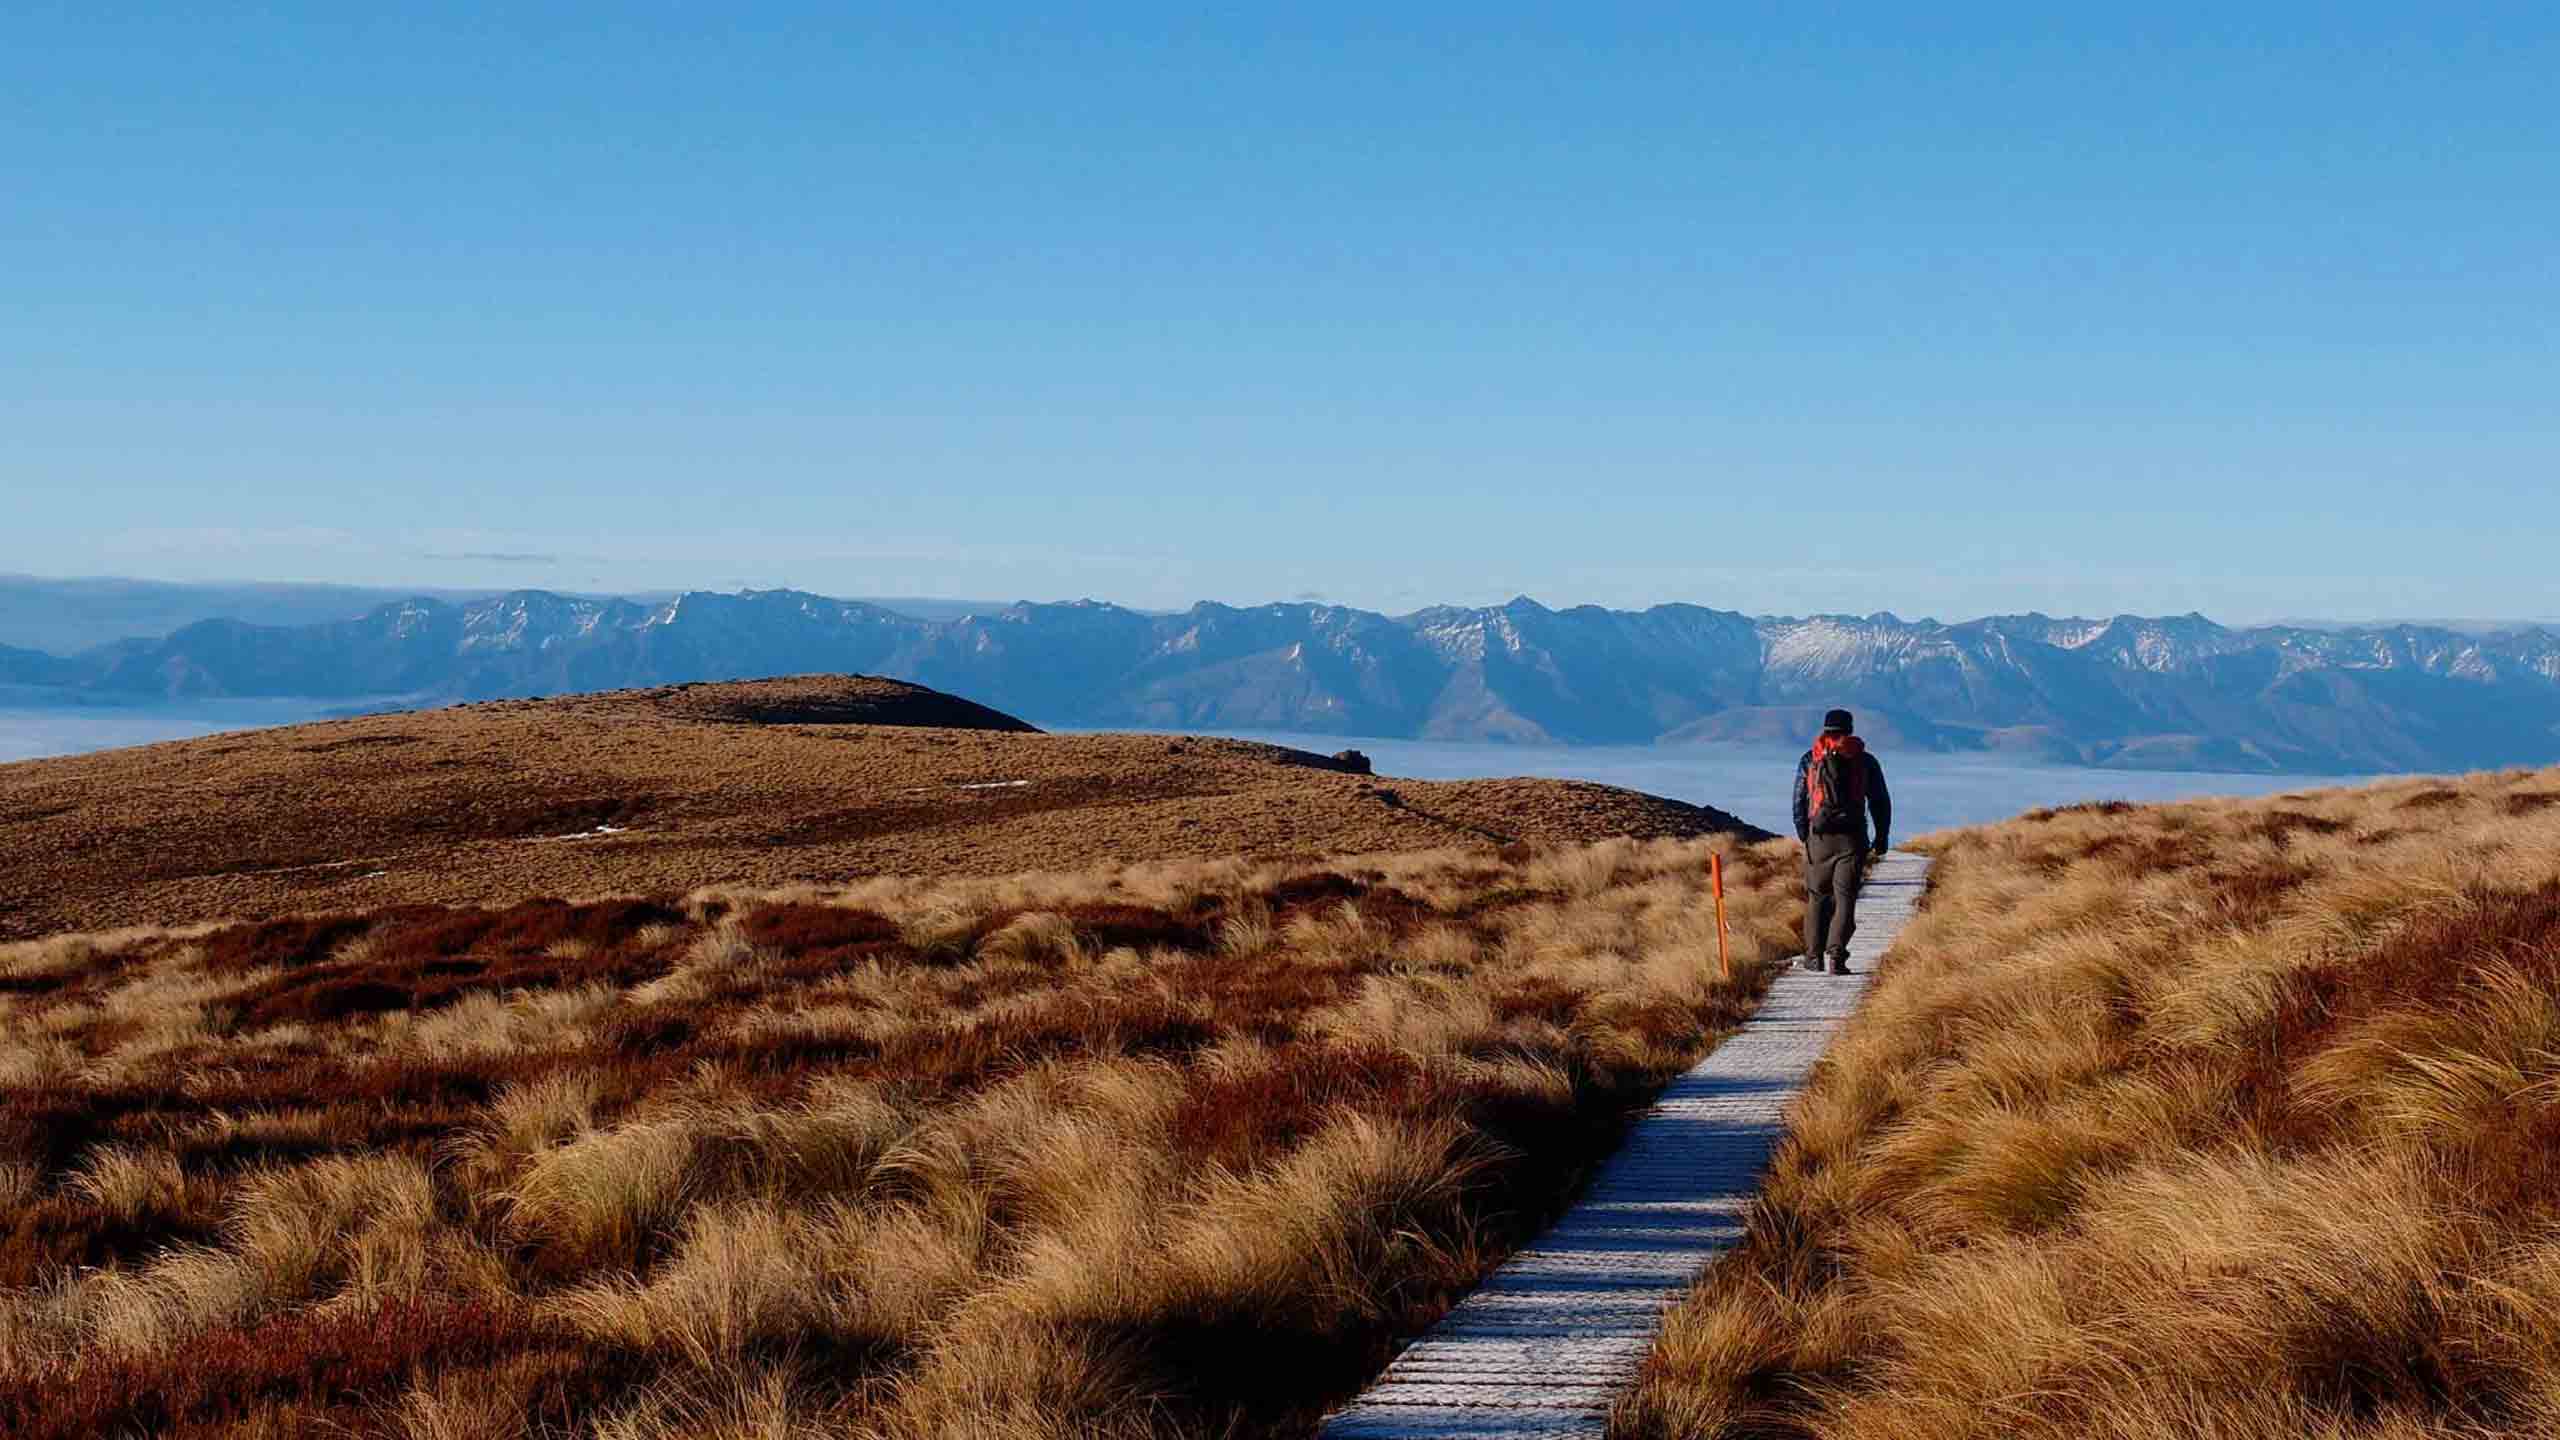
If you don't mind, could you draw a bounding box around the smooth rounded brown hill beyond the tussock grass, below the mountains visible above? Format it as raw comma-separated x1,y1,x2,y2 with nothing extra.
0,676,1759,938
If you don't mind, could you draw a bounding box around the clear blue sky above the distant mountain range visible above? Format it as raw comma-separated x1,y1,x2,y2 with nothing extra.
0,0,2560,620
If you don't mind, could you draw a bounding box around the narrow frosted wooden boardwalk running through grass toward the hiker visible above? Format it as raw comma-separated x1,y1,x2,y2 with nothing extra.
1324,853,1928,1440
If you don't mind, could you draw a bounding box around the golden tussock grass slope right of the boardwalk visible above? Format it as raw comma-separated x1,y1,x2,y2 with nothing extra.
1615,771,2560,1440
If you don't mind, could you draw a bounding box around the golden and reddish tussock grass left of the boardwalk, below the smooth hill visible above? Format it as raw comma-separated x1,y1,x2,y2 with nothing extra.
0,840,1800,1440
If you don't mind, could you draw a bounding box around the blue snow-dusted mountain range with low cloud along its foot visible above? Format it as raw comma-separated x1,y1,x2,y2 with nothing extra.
20,589,2560,774
